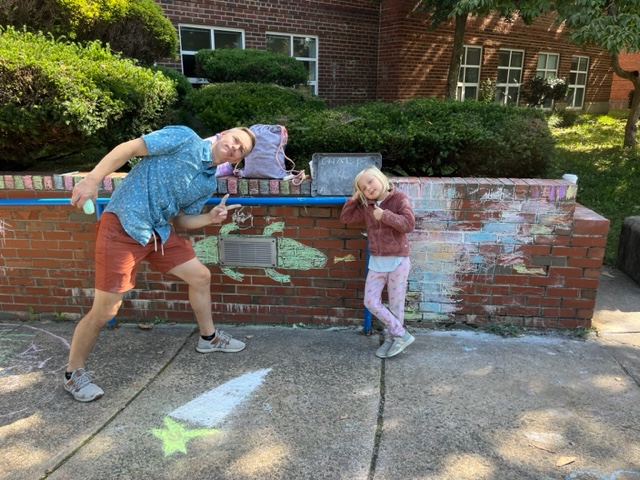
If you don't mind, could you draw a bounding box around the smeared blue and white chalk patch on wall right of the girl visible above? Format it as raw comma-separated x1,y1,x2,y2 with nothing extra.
405,184,576,322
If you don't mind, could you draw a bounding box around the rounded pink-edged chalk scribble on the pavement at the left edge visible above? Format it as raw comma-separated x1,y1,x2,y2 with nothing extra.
0,323,69,427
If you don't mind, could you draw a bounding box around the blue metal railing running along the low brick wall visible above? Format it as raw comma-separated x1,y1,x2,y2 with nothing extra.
0,197,372,334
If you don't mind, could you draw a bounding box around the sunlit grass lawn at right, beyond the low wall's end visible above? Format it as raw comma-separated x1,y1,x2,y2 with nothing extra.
546,110,640,266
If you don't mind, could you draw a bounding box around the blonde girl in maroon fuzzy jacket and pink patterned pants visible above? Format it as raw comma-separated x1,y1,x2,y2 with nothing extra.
340,166,415,358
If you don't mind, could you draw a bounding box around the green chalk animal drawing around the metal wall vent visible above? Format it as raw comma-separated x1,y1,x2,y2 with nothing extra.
193,222,327,283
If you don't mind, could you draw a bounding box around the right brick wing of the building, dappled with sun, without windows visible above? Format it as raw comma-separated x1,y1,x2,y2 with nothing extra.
377,0,612,111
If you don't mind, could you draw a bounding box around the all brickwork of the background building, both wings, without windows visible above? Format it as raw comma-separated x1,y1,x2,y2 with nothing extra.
156,0,611,111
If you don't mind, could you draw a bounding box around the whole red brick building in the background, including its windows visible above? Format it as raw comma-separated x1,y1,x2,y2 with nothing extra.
157,0,612,112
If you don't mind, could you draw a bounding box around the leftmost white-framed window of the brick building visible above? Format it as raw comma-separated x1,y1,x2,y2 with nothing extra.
178,25,244,83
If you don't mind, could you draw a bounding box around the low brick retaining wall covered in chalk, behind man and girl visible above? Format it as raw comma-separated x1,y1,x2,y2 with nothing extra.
0,175,609,328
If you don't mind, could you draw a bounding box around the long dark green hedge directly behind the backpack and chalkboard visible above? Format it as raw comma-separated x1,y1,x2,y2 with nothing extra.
185,83,554,177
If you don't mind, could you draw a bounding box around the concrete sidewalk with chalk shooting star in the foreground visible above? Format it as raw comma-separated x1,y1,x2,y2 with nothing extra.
0,269,640,480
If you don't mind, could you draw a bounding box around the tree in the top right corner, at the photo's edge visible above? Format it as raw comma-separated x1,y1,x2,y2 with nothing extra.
550,0,640,148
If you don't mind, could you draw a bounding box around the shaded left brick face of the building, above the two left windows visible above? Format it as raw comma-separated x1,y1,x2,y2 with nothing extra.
157,0,379,104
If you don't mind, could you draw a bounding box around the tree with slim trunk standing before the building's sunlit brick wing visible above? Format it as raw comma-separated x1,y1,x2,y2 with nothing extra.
417,0,544,99
